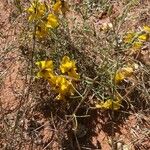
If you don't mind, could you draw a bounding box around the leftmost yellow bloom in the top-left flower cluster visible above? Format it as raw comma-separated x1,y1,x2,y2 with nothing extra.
27,1,47,21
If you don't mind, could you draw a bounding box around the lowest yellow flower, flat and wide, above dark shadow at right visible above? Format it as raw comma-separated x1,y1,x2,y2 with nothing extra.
96,98,121,110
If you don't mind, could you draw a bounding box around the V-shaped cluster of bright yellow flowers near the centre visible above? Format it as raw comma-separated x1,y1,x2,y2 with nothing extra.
36,56,79,100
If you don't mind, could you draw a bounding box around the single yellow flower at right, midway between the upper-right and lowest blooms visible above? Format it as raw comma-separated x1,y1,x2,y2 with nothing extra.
115,67,133,83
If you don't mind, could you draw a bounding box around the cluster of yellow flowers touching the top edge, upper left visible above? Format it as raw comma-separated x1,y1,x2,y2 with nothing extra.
27,0,69,38
